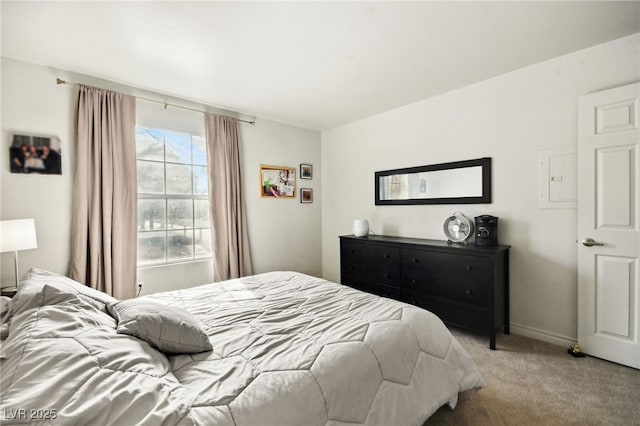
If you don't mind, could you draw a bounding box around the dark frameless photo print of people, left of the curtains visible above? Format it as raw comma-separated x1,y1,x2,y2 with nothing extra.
9,135,62,175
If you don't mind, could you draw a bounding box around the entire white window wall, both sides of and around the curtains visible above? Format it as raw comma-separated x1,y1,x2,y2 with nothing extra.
0,58,322,294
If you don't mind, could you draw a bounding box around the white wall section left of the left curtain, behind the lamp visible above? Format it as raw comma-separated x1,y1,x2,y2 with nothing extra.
0,58,74,286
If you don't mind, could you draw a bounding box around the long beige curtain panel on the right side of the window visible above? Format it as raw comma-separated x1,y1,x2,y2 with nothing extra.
205,114,252,281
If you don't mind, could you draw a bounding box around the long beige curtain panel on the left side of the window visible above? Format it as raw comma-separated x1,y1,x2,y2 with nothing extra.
70,86,137,299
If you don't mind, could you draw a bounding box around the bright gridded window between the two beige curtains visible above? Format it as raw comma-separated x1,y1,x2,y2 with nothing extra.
136,127,211,266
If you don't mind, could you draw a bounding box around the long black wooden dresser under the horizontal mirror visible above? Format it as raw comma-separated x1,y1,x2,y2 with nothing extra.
340,235,510,349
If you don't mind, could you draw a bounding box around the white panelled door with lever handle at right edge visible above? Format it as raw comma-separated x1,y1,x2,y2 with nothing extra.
578,84,640,368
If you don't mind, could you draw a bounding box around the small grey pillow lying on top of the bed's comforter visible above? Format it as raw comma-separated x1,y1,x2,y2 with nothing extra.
109,299,213,354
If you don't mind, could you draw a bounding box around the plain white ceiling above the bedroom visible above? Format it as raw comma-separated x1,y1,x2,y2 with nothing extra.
1,1,640,130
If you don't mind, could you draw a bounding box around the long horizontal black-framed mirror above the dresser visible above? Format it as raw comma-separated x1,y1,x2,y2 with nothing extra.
375,157,491,205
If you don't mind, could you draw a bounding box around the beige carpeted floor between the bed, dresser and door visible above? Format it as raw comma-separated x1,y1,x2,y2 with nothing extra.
423,329,640,426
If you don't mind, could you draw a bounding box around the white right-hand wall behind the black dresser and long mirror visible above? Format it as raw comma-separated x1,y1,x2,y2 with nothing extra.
322,34,640,344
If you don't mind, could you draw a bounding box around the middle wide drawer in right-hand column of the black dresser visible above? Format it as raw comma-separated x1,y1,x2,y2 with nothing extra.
402,270,490,307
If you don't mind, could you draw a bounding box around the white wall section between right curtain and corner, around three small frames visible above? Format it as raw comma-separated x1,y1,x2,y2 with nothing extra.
240,121,322,276
